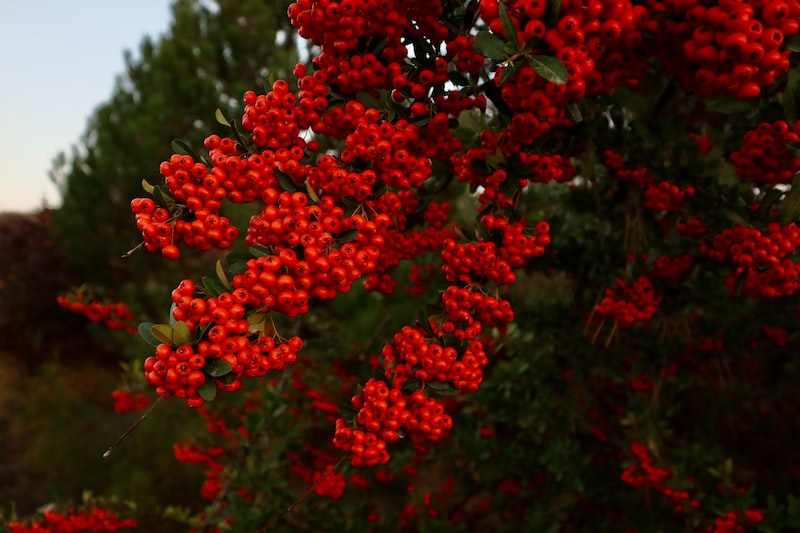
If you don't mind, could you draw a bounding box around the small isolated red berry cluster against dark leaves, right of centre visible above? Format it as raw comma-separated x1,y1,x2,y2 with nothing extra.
594,277,661,329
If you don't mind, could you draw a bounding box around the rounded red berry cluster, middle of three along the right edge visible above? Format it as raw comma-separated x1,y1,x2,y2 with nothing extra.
730,120,800,185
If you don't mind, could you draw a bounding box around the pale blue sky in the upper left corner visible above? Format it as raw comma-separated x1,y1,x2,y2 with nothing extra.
0,0,172,212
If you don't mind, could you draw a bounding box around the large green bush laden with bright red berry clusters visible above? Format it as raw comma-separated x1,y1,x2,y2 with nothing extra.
12,0,800,532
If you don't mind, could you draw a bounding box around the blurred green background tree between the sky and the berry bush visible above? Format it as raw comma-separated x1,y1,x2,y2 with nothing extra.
51,0,298,312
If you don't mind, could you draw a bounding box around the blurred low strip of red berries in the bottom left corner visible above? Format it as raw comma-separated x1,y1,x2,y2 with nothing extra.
7,507,139,533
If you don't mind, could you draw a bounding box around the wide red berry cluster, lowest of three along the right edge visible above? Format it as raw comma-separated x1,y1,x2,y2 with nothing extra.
700,222,800,298
